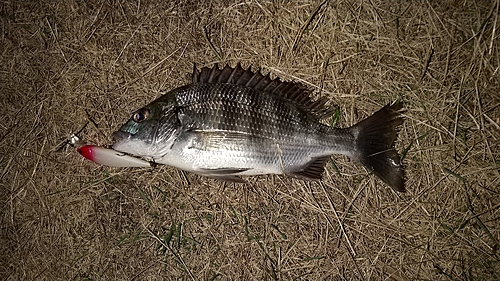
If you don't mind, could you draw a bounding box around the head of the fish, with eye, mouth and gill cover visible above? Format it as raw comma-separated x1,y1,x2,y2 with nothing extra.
113,94,180,161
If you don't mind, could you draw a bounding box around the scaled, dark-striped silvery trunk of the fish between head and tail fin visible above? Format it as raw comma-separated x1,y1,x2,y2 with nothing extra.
157,84,353,178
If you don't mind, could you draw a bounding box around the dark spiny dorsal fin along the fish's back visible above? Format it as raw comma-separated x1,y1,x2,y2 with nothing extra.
192,63,334,120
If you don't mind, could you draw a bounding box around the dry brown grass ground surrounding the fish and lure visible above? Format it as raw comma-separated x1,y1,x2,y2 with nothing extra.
0,0,500,280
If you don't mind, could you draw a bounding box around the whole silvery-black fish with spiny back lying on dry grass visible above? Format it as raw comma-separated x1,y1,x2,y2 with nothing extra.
112,63,405,192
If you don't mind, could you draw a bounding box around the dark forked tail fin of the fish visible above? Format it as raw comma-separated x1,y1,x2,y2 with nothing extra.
350,101,405,192
